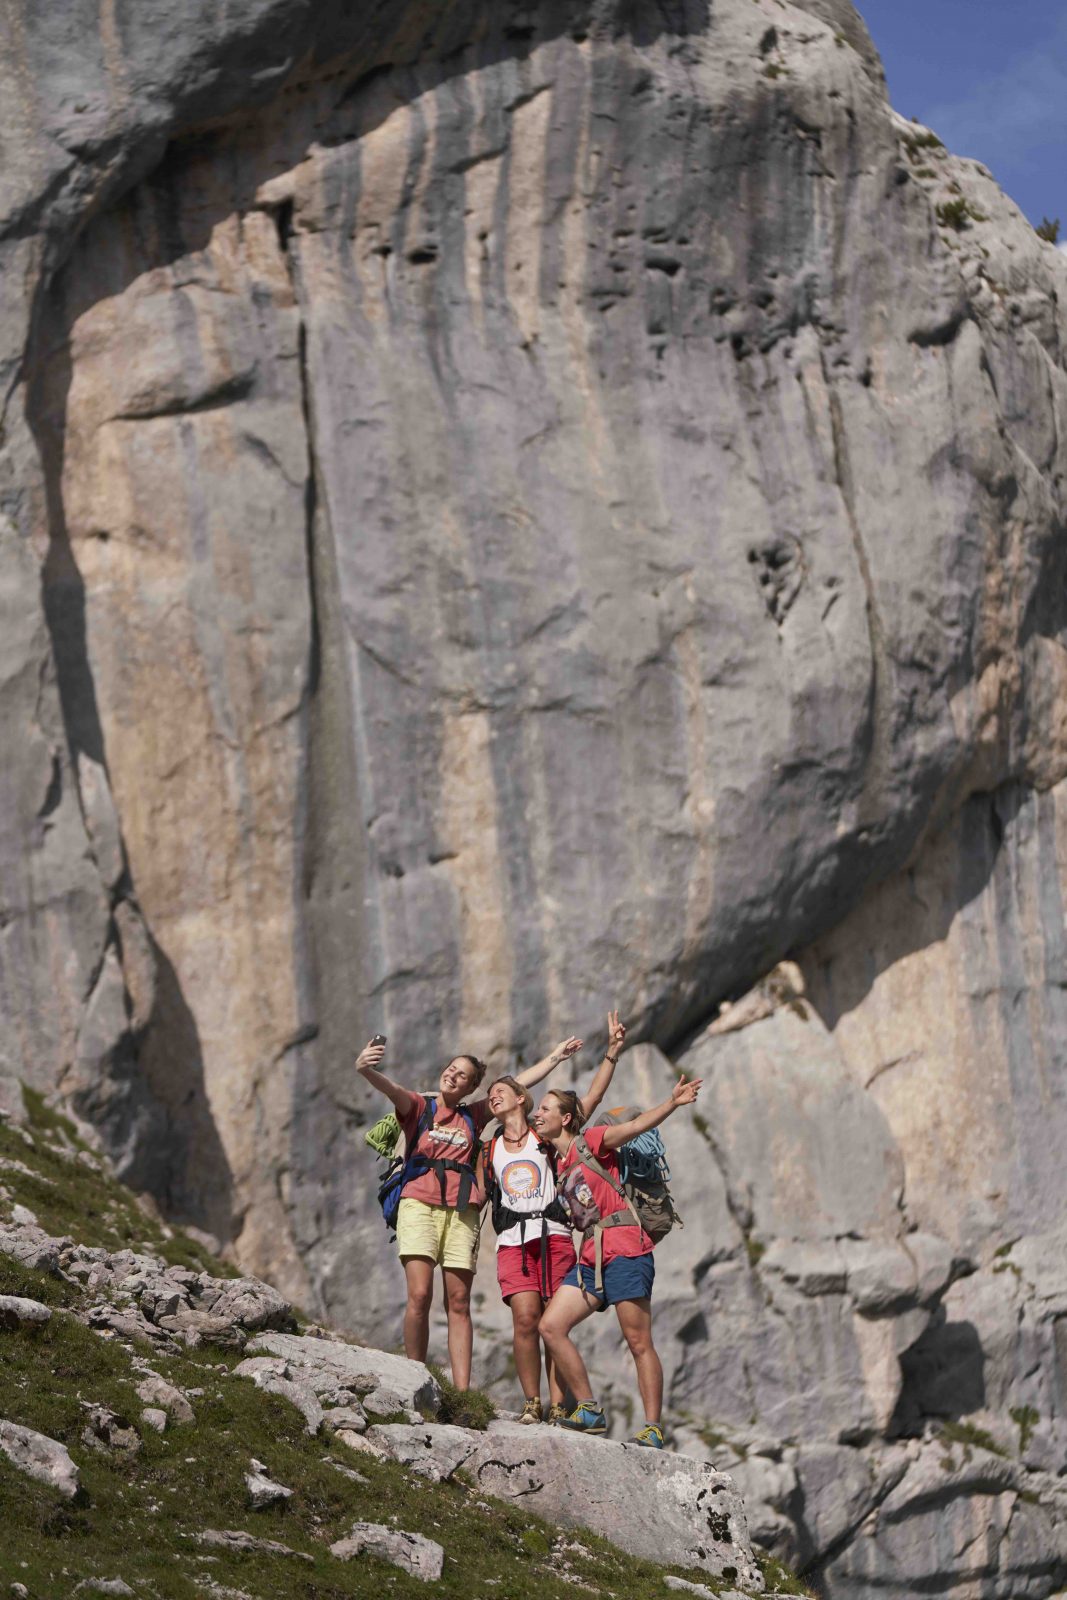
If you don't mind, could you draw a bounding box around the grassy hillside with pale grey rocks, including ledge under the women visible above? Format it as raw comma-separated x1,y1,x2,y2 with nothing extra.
0,1139,765,1600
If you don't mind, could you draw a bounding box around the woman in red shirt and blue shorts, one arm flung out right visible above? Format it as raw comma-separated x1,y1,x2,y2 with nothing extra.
534,1078,704,1450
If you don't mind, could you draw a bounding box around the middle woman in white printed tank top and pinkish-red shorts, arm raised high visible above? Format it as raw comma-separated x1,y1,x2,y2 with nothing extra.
485,1011,625,1422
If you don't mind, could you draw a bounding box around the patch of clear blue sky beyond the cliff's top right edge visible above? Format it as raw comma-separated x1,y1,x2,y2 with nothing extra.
857,0,1067,238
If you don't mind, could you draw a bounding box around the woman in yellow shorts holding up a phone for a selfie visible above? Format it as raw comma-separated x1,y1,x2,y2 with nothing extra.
355,1038,582,1389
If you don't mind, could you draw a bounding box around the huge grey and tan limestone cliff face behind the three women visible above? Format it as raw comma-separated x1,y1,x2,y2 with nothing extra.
0,0,1067,1595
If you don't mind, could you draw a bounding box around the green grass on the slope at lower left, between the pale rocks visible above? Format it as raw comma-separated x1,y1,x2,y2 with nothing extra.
0,1102,808,1600
